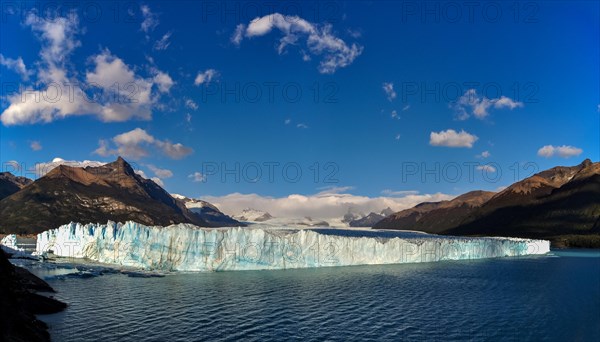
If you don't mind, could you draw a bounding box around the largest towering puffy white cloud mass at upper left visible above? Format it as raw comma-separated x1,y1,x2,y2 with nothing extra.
0,13,174,126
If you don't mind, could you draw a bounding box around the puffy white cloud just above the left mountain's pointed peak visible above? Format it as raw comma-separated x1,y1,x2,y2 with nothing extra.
94,128,194,160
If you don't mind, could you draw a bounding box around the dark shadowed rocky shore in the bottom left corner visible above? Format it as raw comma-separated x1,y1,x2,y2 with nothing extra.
0,250,67,342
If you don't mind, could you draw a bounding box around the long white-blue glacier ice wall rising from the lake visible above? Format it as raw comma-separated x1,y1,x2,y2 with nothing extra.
35,221,550,272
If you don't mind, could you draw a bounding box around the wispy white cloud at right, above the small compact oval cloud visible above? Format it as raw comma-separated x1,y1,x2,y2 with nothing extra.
450,89,523,120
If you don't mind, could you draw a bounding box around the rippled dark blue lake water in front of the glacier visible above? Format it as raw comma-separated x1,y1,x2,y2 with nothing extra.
27,250,600,342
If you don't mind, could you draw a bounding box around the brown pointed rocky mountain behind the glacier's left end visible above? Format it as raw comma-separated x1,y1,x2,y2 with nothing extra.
0,157,239,234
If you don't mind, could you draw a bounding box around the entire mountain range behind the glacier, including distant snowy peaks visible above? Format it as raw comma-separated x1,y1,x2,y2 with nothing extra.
0,157,600,247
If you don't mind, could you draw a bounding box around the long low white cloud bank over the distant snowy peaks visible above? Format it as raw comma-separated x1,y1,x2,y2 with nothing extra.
202,192,454,220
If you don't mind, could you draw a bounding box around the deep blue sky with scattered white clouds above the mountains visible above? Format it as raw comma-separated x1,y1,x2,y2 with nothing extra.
0,1,600,214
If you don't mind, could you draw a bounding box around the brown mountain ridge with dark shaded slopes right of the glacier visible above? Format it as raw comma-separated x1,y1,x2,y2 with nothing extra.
373,159,600,247
